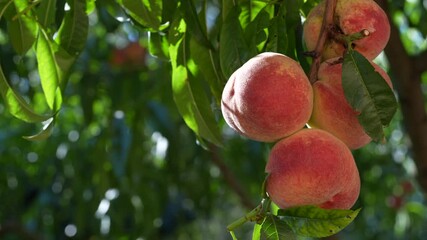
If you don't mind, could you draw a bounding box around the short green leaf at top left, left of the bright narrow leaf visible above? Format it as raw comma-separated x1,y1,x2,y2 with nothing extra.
8,0,37,55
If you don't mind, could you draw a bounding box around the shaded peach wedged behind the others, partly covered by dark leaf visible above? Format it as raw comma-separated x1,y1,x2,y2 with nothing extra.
308,58,392,149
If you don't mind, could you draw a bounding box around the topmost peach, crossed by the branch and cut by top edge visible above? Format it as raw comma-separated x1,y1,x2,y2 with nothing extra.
303,0,390,60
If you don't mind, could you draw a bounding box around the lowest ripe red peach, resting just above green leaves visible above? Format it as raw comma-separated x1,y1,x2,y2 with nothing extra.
266,129,360,209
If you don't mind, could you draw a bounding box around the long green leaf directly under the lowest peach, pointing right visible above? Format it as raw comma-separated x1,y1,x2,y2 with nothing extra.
277,206,360,238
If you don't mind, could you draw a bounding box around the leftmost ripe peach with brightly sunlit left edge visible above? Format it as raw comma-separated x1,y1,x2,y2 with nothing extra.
221,52,313,142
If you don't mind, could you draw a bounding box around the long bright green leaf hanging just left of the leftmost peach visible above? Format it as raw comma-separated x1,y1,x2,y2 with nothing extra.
169,19,221,146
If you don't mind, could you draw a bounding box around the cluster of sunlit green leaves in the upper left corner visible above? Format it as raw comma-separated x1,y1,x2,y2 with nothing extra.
0,0,88,140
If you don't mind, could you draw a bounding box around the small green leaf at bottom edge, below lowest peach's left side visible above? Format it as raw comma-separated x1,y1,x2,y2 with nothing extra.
261,214,297,240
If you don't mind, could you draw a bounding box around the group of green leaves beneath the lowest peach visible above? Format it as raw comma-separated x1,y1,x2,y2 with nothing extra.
228,198,360,240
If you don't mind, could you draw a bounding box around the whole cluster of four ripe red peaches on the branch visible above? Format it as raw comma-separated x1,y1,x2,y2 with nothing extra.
221,0,391,209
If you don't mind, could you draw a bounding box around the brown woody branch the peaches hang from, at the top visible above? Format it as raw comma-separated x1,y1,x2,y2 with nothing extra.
309,0,337,84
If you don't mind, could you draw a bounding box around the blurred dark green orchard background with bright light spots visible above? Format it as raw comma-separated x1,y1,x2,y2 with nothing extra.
0,0,427,240
